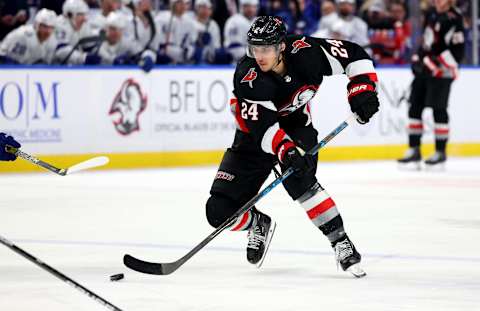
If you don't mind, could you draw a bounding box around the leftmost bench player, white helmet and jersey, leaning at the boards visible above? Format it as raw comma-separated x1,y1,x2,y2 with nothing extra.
0,9,57,64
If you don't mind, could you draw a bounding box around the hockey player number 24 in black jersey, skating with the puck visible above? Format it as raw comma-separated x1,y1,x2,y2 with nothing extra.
206,16,379,277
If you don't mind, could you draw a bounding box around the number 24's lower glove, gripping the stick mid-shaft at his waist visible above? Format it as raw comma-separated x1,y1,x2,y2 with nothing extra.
277,140,315,177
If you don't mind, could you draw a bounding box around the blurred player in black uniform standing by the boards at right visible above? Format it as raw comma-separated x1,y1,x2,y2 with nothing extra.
398,0,464,169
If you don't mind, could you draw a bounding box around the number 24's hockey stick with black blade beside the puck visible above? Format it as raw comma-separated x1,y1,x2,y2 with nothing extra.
123,114,356,275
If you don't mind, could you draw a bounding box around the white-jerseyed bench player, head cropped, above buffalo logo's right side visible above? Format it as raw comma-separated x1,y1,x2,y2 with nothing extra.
122,0,157,49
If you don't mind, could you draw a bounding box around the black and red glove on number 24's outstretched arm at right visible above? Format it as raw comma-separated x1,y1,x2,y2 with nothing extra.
347,75,380,124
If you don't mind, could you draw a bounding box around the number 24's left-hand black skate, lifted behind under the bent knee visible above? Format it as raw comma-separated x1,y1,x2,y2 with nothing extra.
247,211,276,268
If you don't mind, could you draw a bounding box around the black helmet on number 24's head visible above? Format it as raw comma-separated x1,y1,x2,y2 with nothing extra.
247,16,287,45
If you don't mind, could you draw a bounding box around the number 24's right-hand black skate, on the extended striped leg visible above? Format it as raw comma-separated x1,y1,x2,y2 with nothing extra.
332,236,367,278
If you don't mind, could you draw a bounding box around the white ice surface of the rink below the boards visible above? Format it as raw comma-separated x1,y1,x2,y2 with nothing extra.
0,158,480,311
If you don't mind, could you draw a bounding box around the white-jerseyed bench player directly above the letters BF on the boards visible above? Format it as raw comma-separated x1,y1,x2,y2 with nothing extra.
155,0,197,64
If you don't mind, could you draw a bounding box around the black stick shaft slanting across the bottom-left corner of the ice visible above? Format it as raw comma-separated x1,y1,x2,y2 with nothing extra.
0,235,122,311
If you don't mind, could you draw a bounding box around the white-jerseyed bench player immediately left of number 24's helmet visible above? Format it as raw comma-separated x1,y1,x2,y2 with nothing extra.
223,0,258,63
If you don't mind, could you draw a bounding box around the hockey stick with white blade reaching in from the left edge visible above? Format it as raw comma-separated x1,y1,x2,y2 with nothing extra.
5,145,109,176
